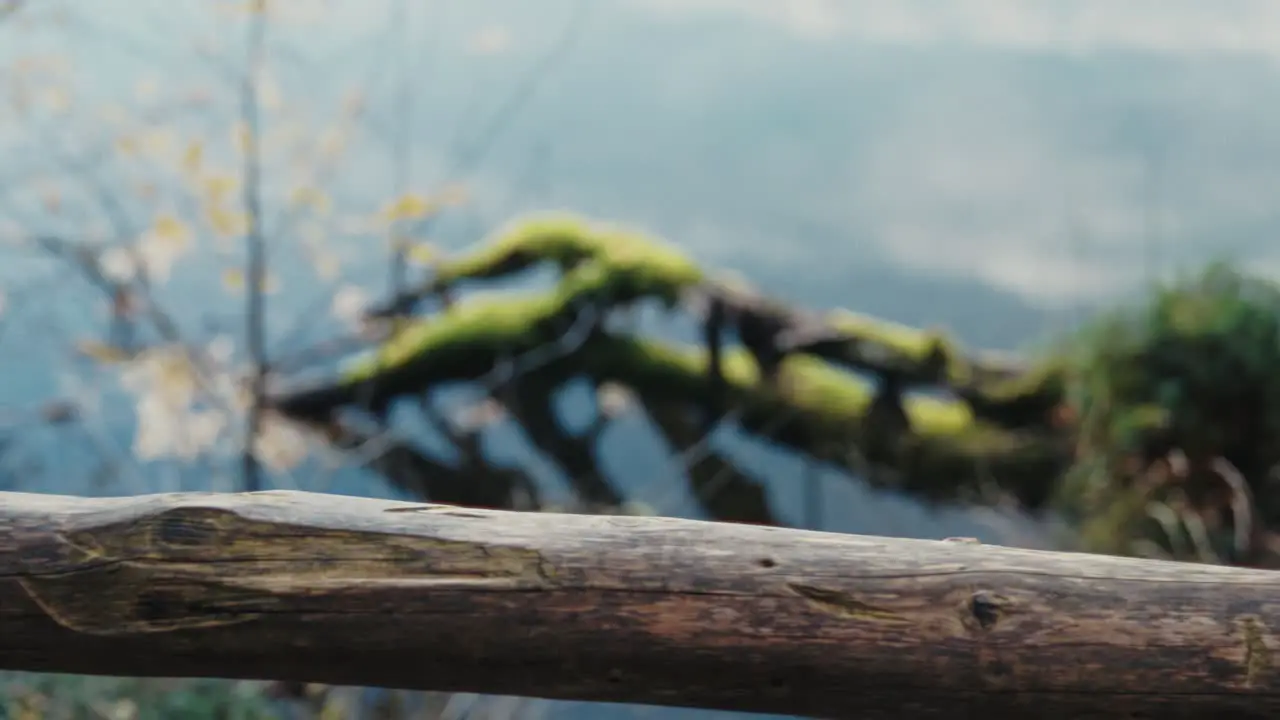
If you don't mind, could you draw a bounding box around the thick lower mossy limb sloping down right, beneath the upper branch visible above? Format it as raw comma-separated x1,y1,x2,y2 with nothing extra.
581,336,1071,510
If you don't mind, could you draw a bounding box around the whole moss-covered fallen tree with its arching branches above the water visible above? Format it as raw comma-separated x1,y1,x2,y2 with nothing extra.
273,210,1070,512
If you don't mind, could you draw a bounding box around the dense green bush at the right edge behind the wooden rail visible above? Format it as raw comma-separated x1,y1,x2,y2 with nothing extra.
1060,260,1280,568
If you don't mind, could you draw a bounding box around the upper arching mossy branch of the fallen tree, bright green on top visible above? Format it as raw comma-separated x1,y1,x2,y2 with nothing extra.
371,214,1064,428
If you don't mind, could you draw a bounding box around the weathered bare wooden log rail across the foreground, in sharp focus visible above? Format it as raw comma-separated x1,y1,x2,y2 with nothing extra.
0,492,1280,719
